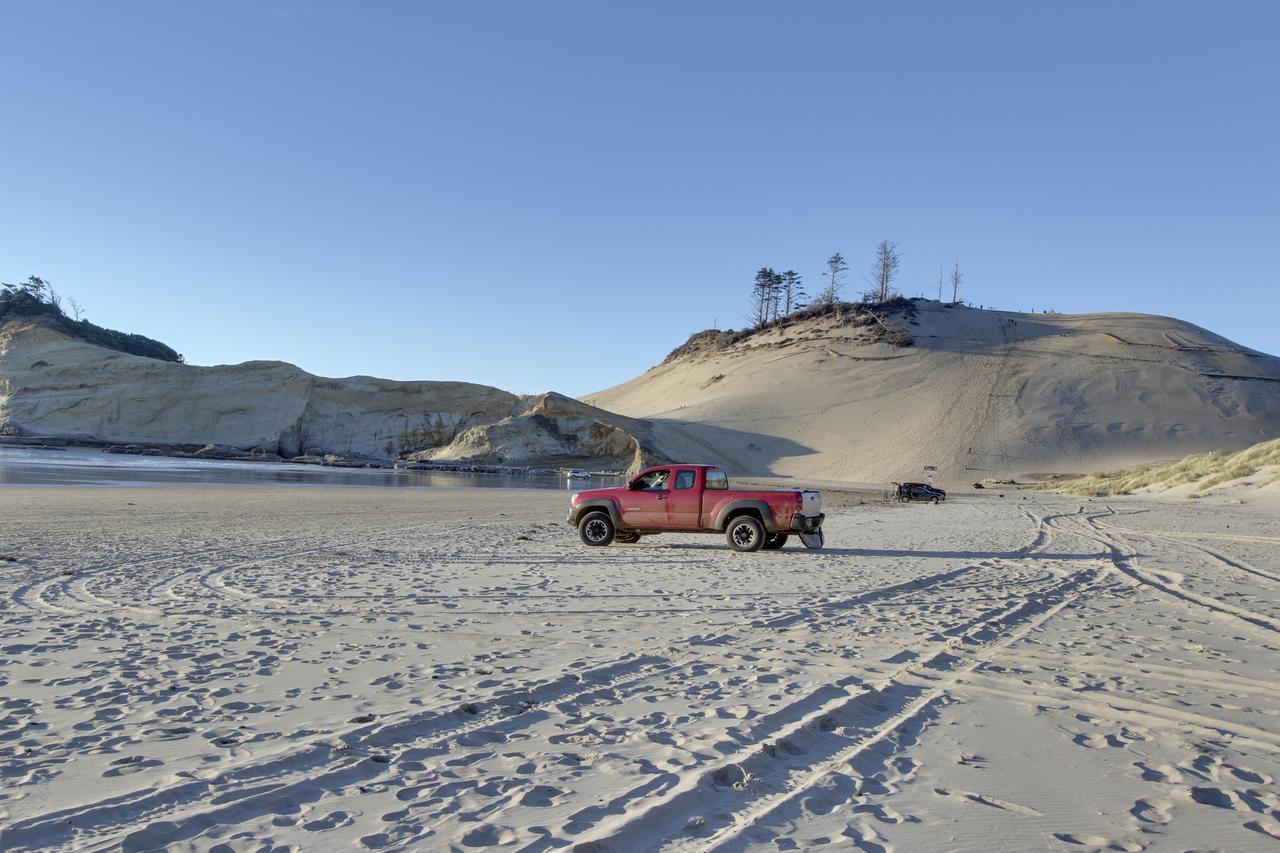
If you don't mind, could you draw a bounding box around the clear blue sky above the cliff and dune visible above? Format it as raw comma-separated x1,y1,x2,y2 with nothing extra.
0,0,1280,394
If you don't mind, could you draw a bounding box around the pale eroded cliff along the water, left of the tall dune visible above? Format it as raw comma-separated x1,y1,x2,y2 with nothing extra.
0,320,648,467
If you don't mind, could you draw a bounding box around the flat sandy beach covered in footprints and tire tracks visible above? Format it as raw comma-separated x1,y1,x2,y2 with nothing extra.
0,485,1280,850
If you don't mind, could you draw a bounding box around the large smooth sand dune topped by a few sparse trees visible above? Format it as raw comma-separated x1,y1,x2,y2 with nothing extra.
585,300,1280,483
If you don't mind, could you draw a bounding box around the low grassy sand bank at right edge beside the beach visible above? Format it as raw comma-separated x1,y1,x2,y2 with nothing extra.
1046,438,1280,497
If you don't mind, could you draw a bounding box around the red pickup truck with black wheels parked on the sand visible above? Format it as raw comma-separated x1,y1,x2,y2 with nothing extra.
568,465,826,551
